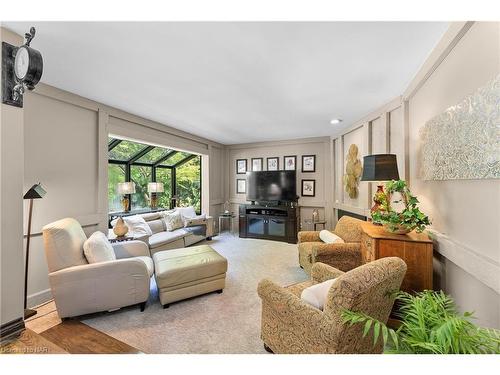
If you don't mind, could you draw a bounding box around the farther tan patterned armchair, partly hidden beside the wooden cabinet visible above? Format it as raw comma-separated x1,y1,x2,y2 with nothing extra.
298,216,364,275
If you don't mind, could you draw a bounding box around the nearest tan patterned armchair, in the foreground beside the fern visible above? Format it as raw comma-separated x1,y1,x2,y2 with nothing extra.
258,257,406,354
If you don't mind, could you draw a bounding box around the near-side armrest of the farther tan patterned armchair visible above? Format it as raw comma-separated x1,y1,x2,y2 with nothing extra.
312,242,361,272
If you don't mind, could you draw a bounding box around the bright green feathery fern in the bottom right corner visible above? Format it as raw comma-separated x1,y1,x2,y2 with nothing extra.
342,290,500,354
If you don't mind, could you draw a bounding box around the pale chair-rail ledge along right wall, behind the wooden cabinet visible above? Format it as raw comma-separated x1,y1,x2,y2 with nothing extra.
428,229,500,294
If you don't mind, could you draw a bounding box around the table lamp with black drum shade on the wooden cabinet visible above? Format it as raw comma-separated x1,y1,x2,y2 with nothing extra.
361,154,399,220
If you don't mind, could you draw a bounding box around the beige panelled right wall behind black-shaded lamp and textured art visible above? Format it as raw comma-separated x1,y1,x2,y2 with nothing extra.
333,22,500,328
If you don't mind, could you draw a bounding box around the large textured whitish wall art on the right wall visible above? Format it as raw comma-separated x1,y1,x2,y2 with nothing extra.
420,75,500,180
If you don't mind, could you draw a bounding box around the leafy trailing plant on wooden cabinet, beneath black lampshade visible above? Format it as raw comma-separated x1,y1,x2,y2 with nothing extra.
372,180,431,234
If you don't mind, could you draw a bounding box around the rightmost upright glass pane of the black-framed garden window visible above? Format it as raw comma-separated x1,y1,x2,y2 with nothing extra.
176,156,201,212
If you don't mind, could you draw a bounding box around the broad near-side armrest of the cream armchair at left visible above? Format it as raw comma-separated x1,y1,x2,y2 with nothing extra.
49,258,150,318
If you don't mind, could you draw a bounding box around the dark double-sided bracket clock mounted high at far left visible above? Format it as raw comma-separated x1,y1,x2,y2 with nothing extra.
2,27,43,107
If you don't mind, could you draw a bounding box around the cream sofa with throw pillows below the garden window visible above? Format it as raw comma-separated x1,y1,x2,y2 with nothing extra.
110,207,214,256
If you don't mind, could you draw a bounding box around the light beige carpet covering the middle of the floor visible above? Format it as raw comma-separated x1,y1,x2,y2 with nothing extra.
82,234,307,354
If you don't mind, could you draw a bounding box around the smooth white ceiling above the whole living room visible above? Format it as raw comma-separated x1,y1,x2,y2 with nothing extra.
2,22,448,144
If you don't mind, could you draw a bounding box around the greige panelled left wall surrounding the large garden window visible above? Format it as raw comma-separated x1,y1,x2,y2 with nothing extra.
22,84,224,306
